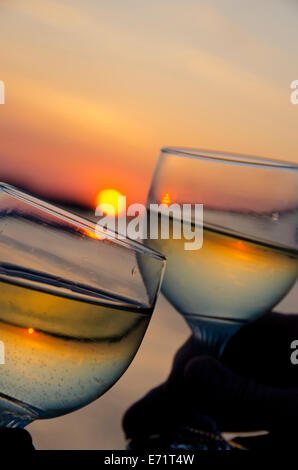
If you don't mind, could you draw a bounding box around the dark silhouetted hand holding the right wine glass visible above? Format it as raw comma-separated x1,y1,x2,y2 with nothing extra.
123,313,298,448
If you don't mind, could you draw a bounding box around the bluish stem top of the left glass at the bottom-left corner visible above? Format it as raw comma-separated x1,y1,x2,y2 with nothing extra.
0,393,40,428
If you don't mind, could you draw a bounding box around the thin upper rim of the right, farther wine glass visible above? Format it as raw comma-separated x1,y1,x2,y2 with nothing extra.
161,146,298,171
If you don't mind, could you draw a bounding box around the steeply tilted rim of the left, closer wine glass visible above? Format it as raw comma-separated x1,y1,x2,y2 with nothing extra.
0,181,166,261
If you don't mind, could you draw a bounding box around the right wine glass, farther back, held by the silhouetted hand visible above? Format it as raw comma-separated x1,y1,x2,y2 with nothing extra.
146,147,298,356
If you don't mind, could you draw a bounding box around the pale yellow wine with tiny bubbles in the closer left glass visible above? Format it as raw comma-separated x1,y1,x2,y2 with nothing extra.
0,281,151,422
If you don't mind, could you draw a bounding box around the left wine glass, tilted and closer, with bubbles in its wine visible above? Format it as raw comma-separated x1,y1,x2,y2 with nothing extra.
0,183,165,427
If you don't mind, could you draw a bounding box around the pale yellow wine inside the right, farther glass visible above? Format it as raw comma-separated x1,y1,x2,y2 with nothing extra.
145,214,298,325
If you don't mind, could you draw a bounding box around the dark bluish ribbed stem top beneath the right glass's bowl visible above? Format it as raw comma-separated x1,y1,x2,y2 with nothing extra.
186,315,243,358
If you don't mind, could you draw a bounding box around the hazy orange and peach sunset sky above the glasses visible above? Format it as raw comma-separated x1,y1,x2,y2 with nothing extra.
0,0,298,204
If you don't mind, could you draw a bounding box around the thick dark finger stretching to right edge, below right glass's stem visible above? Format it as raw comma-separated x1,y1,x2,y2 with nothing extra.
180,357,298,430
